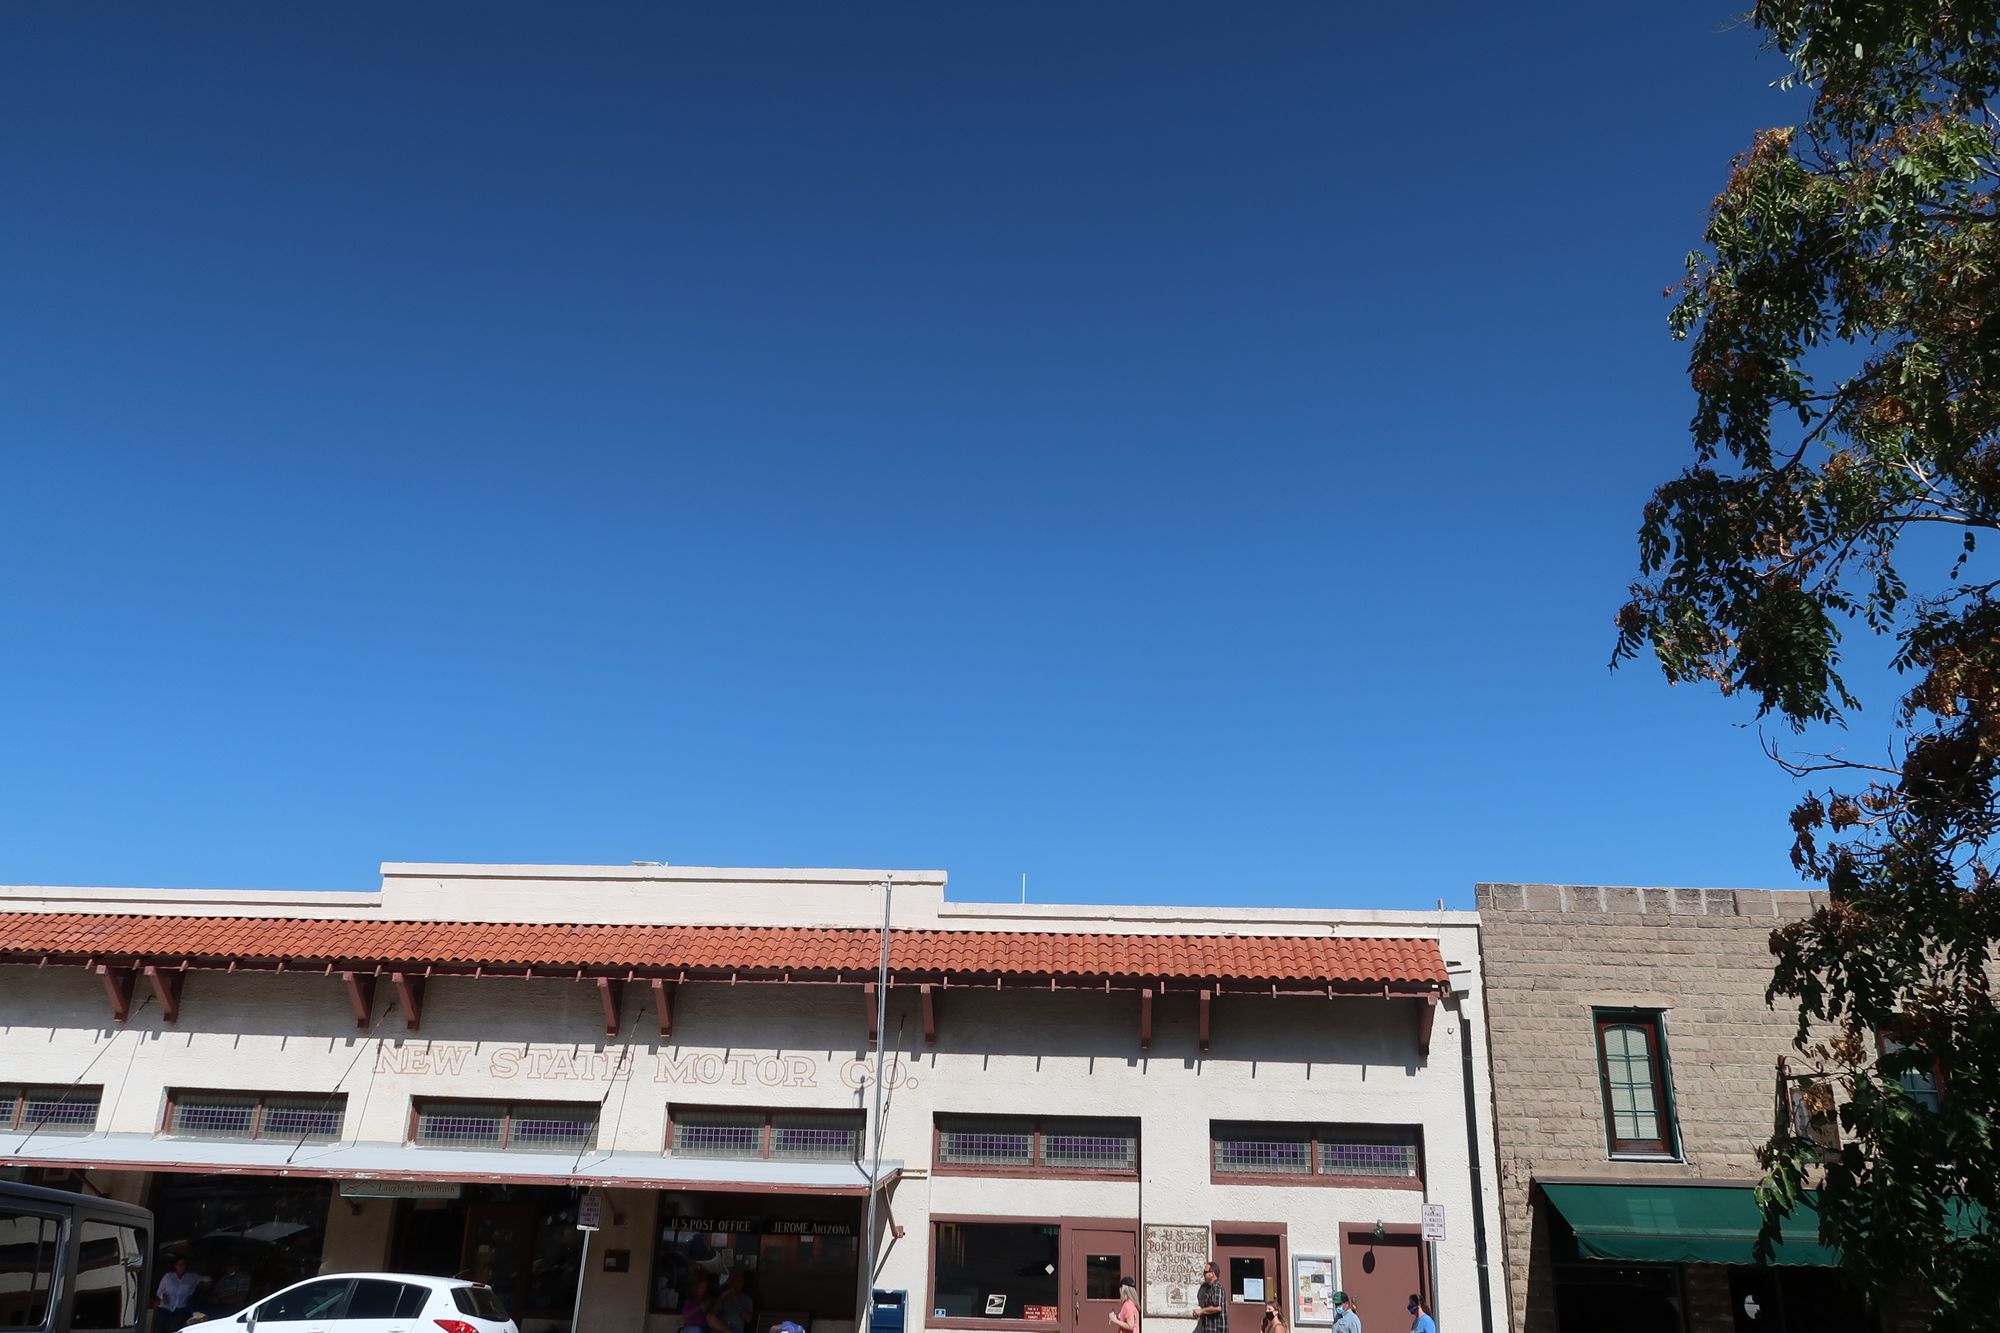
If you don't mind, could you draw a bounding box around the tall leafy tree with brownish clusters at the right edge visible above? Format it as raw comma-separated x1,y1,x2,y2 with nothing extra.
1614,0,2000,1329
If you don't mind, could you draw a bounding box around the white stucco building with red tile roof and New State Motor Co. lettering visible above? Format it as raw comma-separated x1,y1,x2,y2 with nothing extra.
0,865,1506,1333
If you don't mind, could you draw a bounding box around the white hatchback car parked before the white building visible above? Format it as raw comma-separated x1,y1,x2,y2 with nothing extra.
188,1273,520,1333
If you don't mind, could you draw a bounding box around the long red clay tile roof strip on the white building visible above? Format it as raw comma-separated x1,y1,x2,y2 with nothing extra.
0,911,1446,987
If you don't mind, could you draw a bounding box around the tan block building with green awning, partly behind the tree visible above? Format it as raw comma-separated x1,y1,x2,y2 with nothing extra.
1478,885,1904,1333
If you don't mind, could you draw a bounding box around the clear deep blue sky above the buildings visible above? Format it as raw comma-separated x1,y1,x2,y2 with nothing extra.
0,0,1840,907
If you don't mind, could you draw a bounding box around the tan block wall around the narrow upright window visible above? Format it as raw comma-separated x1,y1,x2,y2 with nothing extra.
1478,885,1822,1333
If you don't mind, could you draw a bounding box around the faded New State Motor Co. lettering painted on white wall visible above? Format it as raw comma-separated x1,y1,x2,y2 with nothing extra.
376,1041,916,1091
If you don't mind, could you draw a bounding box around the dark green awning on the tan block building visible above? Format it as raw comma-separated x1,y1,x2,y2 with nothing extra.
1542,1183,1840,1267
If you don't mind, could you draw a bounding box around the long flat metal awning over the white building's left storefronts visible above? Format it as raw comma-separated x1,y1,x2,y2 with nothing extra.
0,1133,902,1199
